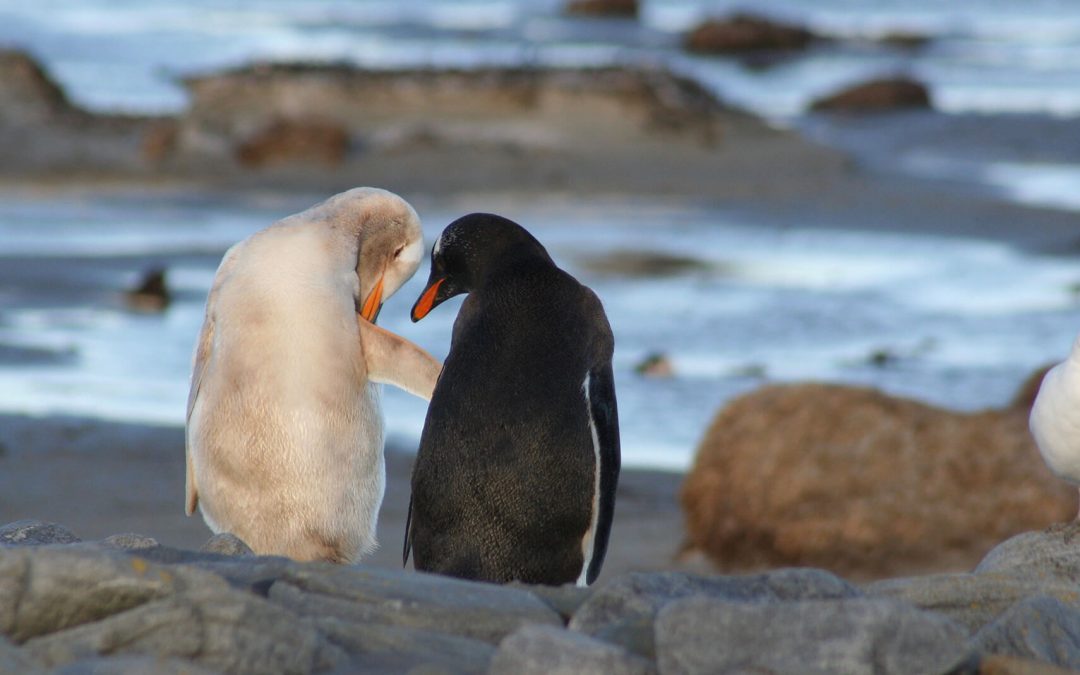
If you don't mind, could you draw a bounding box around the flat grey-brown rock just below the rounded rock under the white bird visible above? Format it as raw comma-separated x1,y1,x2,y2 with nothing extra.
863,572,1080,634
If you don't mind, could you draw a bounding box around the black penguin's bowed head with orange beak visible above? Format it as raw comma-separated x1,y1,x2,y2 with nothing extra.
413,213,551,322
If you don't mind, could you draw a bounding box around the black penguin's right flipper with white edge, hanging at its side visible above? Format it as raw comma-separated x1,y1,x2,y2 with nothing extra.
585,361,620,584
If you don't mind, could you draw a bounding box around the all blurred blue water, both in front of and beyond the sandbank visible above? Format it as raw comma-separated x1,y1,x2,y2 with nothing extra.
0,0,1080,469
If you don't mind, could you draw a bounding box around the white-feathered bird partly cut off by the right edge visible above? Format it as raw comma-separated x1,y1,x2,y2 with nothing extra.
1028,338,1080,521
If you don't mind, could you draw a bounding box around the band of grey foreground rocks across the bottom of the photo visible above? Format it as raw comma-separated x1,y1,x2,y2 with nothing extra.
0,521,1080,675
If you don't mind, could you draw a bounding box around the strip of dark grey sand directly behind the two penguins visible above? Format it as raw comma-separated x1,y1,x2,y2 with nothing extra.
0,416,692,580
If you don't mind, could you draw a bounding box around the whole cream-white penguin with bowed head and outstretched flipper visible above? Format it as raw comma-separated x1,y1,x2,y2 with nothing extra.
186,188,441,563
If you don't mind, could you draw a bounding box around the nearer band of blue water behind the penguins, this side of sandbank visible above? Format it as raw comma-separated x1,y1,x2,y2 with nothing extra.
0,192,1080,469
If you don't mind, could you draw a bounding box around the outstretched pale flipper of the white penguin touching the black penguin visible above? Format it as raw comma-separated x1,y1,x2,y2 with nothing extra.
356,315,443,401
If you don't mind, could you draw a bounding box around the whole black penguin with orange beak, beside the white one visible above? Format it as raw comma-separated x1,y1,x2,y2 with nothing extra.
403,214,620,585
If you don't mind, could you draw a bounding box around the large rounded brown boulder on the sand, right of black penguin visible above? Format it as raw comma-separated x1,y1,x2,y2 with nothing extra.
680,369,1077,578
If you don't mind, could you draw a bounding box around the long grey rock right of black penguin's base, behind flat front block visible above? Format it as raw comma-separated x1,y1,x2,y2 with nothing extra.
569,568,860,658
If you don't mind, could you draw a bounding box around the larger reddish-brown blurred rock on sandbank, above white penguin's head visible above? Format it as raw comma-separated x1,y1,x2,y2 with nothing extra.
235,119,349,167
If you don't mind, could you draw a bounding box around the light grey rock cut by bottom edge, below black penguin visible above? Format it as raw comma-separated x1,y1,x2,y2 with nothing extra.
488,625,656,675
